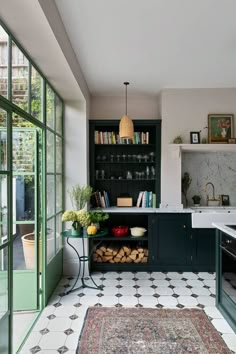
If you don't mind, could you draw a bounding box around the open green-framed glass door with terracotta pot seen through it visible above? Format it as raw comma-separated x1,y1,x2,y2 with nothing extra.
12,115,41,311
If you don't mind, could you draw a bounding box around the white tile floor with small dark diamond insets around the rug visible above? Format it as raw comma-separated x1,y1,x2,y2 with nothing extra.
19,272,236,354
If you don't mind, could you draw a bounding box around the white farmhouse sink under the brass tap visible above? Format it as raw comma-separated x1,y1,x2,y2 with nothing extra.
192,207,236,229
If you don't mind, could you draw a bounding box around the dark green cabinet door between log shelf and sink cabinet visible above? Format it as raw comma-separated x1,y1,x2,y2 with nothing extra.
153,213,191,271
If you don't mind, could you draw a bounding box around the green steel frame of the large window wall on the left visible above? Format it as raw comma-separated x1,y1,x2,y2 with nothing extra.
0,19,65,353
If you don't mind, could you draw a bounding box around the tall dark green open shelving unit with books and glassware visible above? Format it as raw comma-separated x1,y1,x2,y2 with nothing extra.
89,120,161,207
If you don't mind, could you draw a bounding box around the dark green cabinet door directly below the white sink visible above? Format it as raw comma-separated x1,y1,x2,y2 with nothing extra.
192,229,216,272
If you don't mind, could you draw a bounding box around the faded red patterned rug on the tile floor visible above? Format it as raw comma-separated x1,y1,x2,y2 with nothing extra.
76,307,230,354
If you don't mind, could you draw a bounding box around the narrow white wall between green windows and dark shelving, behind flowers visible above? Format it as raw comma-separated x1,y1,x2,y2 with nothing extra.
63,101,89,275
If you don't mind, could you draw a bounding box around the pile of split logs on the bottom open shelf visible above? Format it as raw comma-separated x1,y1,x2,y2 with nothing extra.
93,243,148,263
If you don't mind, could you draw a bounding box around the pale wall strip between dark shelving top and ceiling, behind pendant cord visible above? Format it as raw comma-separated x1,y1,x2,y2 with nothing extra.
90,96,161,119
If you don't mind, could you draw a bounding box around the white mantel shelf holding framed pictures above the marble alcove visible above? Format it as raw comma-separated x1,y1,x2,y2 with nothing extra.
170,144,236,152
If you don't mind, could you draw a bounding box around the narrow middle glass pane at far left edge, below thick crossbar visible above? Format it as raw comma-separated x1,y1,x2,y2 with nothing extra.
0,175,8,246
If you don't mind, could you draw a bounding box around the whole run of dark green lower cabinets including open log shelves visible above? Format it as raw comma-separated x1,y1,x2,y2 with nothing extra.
90,213,215,272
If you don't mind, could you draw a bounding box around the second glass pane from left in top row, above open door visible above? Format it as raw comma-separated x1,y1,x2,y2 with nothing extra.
12,42,29,112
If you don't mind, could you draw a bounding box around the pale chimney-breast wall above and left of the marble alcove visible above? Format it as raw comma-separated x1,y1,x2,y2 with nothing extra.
161,88,236,206
